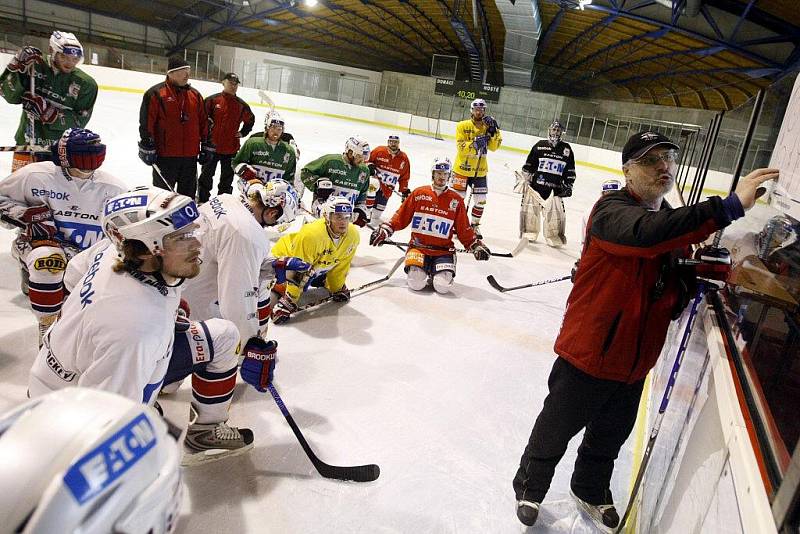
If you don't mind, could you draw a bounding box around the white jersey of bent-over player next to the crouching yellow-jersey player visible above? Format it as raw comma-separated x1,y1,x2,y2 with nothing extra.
183,194,271,340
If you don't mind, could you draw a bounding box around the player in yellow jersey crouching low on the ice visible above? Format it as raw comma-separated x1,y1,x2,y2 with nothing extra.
272,196,360,324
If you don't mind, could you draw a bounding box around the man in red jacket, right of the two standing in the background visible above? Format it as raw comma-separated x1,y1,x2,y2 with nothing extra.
197,72,256,204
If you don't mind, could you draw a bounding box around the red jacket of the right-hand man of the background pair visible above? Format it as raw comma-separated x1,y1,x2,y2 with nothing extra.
205,93,256,155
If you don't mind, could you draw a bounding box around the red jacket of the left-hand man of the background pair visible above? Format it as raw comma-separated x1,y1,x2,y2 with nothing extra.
139,79,208,157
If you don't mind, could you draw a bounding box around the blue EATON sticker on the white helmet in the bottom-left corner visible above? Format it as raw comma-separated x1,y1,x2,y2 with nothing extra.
64,414,156,504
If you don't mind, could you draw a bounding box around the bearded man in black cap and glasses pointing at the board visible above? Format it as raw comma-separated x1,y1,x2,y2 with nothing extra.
513,132,778,531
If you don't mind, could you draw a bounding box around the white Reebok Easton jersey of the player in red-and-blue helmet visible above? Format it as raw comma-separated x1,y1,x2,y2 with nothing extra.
0,161,130,250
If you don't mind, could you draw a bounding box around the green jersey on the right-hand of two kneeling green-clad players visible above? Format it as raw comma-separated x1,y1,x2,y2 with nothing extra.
300,154,369,213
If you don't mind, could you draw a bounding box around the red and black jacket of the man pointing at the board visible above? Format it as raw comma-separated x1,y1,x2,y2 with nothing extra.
554,189,730,383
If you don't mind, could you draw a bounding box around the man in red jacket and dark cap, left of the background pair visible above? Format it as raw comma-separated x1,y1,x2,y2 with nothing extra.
139,57,216,198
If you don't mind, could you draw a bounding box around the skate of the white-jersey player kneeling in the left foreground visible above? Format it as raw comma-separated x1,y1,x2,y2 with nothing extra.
181,421,253,467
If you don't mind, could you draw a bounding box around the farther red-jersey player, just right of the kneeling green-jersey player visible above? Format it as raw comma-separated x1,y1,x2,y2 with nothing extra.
367,135,411,222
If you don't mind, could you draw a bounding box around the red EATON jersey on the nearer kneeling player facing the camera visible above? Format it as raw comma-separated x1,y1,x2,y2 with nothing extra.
389,185,478,256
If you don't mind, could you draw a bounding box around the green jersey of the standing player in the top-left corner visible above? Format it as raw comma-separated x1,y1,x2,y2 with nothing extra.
0,63,97,148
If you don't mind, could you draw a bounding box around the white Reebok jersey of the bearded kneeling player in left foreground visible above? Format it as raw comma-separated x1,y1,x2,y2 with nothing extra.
29,239,180,404
